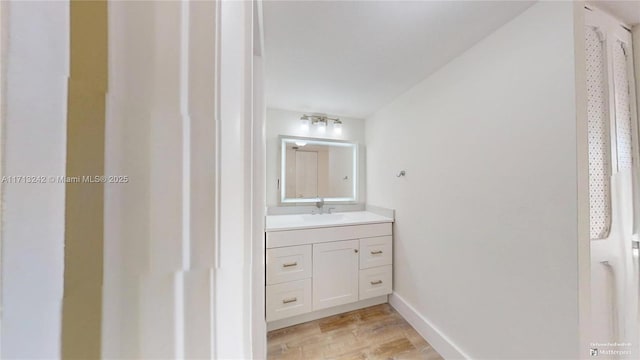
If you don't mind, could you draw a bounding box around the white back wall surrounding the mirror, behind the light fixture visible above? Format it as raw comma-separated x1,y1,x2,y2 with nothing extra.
266,108,366,206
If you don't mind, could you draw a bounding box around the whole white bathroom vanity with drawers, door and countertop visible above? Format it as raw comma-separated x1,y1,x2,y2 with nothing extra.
265,211,393,330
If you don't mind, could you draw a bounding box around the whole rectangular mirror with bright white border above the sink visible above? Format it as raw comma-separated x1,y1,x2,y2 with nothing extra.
280,136,358,203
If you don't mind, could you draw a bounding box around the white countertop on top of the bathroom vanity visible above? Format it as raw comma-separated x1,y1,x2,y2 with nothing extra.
266,211,393,231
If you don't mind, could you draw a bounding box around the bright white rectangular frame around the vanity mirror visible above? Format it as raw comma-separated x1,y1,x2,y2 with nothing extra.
278,135,360,204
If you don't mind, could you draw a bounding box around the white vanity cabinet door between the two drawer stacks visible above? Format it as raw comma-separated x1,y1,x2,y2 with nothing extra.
313,240,360,310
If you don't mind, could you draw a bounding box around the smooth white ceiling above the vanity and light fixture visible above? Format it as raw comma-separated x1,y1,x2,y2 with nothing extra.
263,1,533,118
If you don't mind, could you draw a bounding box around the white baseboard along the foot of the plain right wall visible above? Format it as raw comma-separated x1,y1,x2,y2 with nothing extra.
389,292,470,359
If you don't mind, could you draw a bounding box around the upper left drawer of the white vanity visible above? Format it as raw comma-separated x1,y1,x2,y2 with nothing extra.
267,245,311,285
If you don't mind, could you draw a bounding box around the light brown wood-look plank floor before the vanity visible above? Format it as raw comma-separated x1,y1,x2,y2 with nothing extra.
267,304,442,360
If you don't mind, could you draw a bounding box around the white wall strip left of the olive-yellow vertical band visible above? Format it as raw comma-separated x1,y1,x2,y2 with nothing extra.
0,1,69,359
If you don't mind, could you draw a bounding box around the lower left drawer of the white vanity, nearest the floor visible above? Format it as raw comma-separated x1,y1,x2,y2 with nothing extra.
266,279,311,321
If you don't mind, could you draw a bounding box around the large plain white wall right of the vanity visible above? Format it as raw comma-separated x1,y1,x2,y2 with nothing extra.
367,2,588,359
